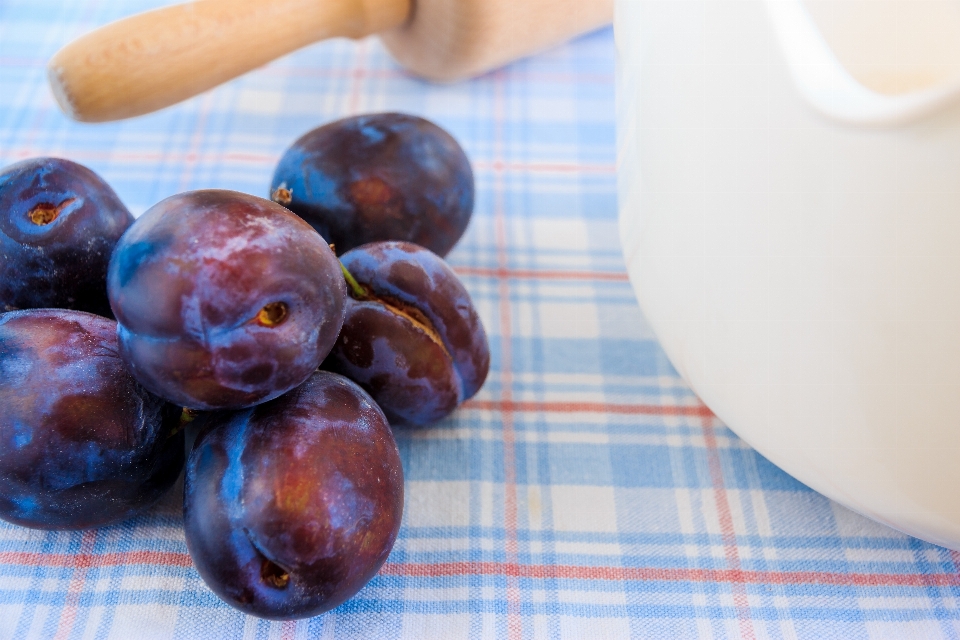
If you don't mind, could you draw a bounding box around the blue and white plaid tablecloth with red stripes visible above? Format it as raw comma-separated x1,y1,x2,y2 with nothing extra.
0,0,960,640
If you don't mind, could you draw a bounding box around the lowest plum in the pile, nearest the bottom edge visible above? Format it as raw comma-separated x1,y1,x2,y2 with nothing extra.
184,371,403,619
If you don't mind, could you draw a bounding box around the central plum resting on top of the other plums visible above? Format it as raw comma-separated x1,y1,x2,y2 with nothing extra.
107,190,346,410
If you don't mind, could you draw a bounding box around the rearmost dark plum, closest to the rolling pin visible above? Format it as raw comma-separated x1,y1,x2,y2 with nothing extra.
270,113,474,256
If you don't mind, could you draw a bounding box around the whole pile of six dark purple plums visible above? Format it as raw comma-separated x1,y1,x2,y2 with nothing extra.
0,114,490,619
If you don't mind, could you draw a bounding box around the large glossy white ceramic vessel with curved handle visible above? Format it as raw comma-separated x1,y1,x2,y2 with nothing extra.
615,0,960,549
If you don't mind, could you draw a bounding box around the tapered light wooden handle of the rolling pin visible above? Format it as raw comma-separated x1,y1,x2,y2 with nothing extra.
48,0,410,122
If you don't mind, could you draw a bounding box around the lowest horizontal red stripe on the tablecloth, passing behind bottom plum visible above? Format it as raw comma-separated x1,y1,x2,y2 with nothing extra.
0,551,960,587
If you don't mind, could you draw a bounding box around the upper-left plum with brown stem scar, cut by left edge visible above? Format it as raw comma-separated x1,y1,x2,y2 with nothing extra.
0,158,133,317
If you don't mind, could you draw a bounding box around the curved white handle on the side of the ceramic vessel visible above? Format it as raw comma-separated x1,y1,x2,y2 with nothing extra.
765,0,960,127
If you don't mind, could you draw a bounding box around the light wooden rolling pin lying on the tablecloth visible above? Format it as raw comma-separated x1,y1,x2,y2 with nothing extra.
48,0,613,122
